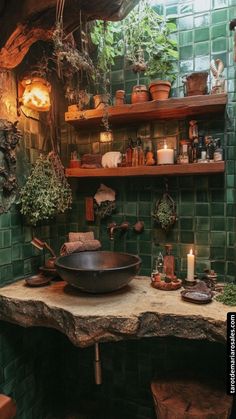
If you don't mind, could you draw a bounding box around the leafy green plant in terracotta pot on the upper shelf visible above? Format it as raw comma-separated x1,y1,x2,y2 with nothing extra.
124,0,178,99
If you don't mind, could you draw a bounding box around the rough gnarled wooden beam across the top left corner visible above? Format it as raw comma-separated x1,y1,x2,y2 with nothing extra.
0,0,139,69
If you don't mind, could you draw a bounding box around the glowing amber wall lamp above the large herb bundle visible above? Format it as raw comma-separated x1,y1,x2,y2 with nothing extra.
22,77,51,112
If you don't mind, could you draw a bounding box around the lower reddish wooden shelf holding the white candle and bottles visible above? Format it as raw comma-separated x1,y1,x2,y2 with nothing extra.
66,161,225,178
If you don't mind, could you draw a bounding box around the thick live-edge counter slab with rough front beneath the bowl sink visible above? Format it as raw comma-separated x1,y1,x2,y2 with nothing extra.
0,277,232,347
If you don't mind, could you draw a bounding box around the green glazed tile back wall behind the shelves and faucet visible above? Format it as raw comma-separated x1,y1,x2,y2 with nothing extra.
59,0,236,281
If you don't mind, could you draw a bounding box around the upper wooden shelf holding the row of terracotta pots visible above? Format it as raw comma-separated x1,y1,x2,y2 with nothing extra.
65,93,227,127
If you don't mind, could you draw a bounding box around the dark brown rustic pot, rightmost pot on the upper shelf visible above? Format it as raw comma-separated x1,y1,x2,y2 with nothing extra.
183,71,208,96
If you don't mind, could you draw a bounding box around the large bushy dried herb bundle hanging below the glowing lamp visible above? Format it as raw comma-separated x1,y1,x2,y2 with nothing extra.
20,152,72,225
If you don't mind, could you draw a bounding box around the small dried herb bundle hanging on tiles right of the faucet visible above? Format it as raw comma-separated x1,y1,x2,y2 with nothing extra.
152,192,177,231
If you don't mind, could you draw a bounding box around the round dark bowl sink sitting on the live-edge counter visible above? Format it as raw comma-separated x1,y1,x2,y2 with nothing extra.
55,251,141,293
